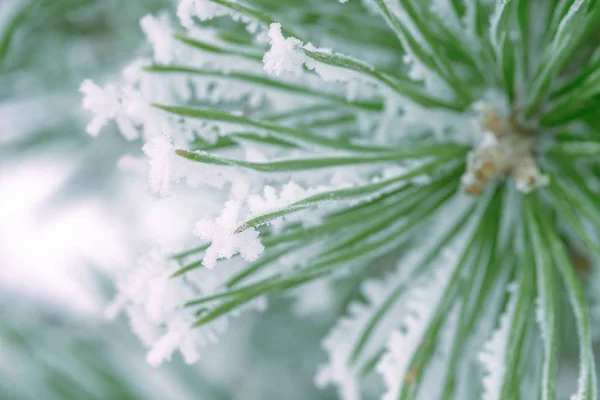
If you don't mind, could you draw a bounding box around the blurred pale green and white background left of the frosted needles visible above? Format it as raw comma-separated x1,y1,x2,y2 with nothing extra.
0,0,335,400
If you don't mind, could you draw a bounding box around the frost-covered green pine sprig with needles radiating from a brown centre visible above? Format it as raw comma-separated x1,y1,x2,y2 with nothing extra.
81,0,600,400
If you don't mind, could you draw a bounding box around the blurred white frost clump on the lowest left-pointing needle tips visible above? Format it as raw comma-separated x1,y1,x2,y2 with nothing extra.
106,247,239,367
